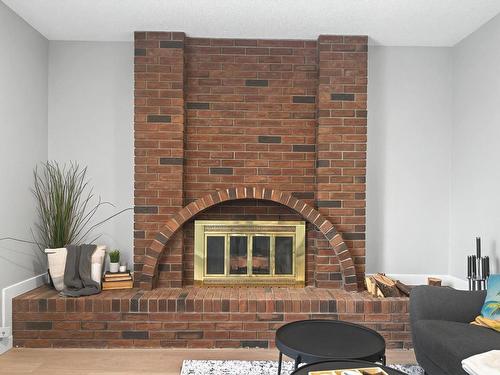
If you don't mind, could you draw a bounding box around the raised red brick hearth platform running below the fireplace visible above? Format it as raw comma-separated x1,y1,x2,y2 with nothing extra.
13,287,411,348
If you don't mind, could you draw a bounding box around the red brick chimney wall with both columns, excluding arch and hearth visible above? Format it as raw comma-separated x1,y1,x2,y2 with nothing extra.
135,32,367,288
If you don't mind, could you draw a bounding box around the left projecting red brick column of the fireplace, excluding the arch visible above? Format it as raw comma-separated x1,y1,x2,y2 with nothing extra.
134,32,185,287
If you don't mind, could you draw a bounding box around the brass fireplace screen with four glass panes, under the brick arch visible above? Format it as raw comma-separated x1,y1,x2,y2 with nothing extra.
194,220,305,286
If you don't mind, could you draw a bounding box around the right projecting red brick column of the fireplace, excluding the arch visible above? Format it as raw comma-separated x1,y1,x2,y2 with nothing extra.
316,35,368,285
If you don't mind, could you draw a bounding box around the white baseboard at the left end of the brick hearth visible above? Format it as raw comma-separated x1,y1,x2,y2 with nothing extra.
0,273,47,355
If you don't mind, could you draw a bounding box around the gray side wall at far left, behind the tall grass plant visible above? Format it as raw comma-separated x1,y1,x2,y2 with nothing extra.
0,2,48,312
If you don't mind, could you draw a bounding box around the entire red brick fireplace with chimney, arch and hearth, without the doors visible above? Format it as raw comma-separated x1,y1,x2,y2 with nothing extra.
13,32,411,348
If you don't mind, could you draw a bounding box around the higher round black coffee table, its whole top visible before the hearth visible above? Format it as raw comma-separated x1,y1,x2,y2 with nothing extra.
276,320,385,375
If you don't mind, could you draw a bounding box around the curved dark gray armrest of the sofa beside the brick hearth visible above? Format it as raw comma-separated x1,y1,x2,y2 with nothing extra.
410,285,486,325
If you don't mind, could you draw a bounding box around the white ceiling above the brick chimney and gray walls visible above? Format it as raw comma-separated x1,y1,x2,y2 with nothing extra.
3,0,500,46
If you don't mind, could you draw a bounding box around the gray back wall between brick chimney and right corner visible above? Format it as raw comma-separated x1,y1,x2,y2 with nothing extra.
367,47,452,274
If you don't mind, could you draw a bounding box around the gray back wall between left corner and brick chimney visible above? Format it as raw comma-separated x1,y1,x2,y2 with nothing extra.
48,41,134,264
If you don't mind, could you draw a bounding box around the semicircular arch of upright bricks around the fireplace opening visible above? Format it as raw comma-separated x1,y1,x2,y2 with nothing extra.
139,187,358,291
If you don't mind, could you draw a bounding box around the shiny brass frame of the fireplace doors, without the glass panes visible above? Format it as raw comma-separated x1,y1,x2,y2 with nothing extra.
194,220,306,286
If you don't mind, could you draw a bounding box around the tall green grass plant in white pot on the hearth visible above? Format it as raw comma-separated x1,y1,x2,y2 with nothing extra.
0,161,132,290
